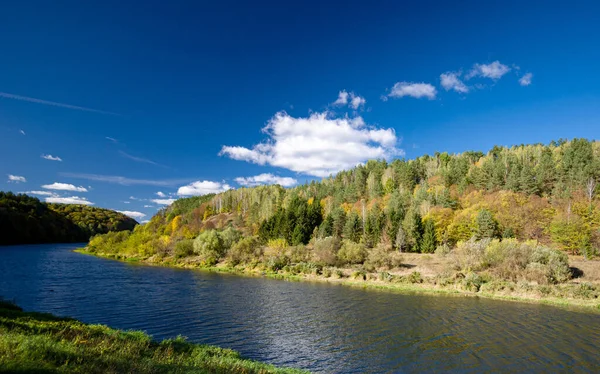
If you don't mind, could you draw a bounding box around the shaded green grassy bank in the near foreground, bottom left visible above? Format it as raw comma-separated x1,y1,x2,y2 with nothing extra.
0,300,300,373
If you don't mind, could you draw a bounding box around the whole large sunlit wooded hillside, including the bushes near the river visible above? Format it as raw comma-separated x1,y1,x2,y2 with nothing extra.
87,139,600,306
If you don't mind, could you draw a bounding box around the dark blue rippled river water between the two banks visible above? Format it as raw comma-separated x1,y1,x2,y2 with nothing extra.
0,244,600,373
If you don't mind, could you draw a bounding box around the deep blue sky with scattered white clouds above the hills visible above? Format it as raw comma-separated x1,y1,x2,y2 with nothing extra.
0,1,600,221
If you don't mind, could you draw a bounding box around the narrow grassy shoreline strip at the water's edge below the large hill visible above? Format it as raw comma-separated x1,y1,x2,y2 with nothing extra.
74,248,600,313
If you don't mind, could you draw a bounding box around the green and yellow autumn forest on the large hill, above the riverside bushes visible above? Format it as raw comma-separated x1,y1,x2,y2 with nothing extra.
90,139,600,263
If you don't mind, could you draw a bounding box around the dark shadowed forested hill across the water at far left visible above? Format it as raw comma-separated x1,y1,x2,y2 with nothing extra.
0,191,137,245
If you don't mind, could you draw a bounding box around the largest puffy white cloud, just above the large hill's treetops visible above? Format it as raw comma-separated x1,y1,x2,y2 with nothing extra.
219,112,404,177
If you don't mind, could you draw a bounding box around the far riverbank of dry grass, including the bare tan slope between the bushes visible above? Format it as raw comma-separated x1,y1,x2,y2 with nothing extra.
76,248,600,312
